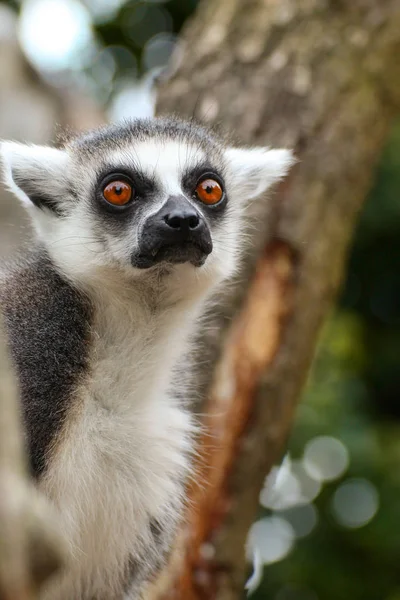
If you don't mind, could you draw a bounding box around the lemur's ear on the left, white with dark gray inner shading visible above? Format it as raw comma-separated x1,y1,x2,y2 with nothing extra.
0,142,69,213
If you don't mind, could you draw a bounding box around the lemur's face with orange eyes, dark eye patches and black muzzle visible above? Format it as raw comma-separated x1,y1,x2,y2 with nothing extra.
81,138,229,270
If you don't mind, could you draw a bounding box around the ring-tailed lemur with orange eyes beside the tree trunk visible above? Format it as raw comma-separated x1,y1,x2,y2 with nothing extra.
0,119,293,600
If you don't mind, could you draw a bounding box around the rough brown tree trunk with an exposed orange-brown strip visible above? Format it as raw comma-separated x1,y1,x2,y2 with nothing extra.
155,0,400,600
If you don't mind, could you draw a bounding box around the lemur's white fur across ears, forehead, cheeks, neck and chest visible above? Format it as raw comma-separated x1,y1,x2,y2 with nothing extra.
1,127,293,600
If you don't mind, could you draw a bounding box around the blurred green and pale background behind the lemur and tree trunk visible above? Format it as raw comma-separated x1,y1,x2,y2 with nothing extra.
0,0,400,600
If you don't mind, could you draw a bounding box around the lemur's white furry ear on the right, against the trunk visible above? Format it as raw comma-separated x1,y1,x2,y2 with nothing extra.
225,147,296,200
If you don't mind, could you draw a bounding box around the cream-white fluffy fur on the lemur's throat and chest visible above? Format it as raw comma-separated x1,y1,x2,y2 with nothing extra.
43,284,192,589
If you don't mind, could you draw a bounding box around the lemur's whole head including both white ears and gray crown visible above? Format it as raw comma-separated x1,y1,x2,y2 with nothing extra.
1,119,293,292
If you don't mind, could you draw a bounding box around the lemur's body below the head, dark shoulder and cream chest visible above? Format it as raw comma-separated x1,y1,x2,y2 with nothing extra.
1,258,193,600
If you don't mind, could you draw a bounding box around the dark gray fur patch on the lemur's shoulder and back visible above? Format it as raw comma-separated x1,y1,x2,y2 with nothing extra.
0,249,92,477
